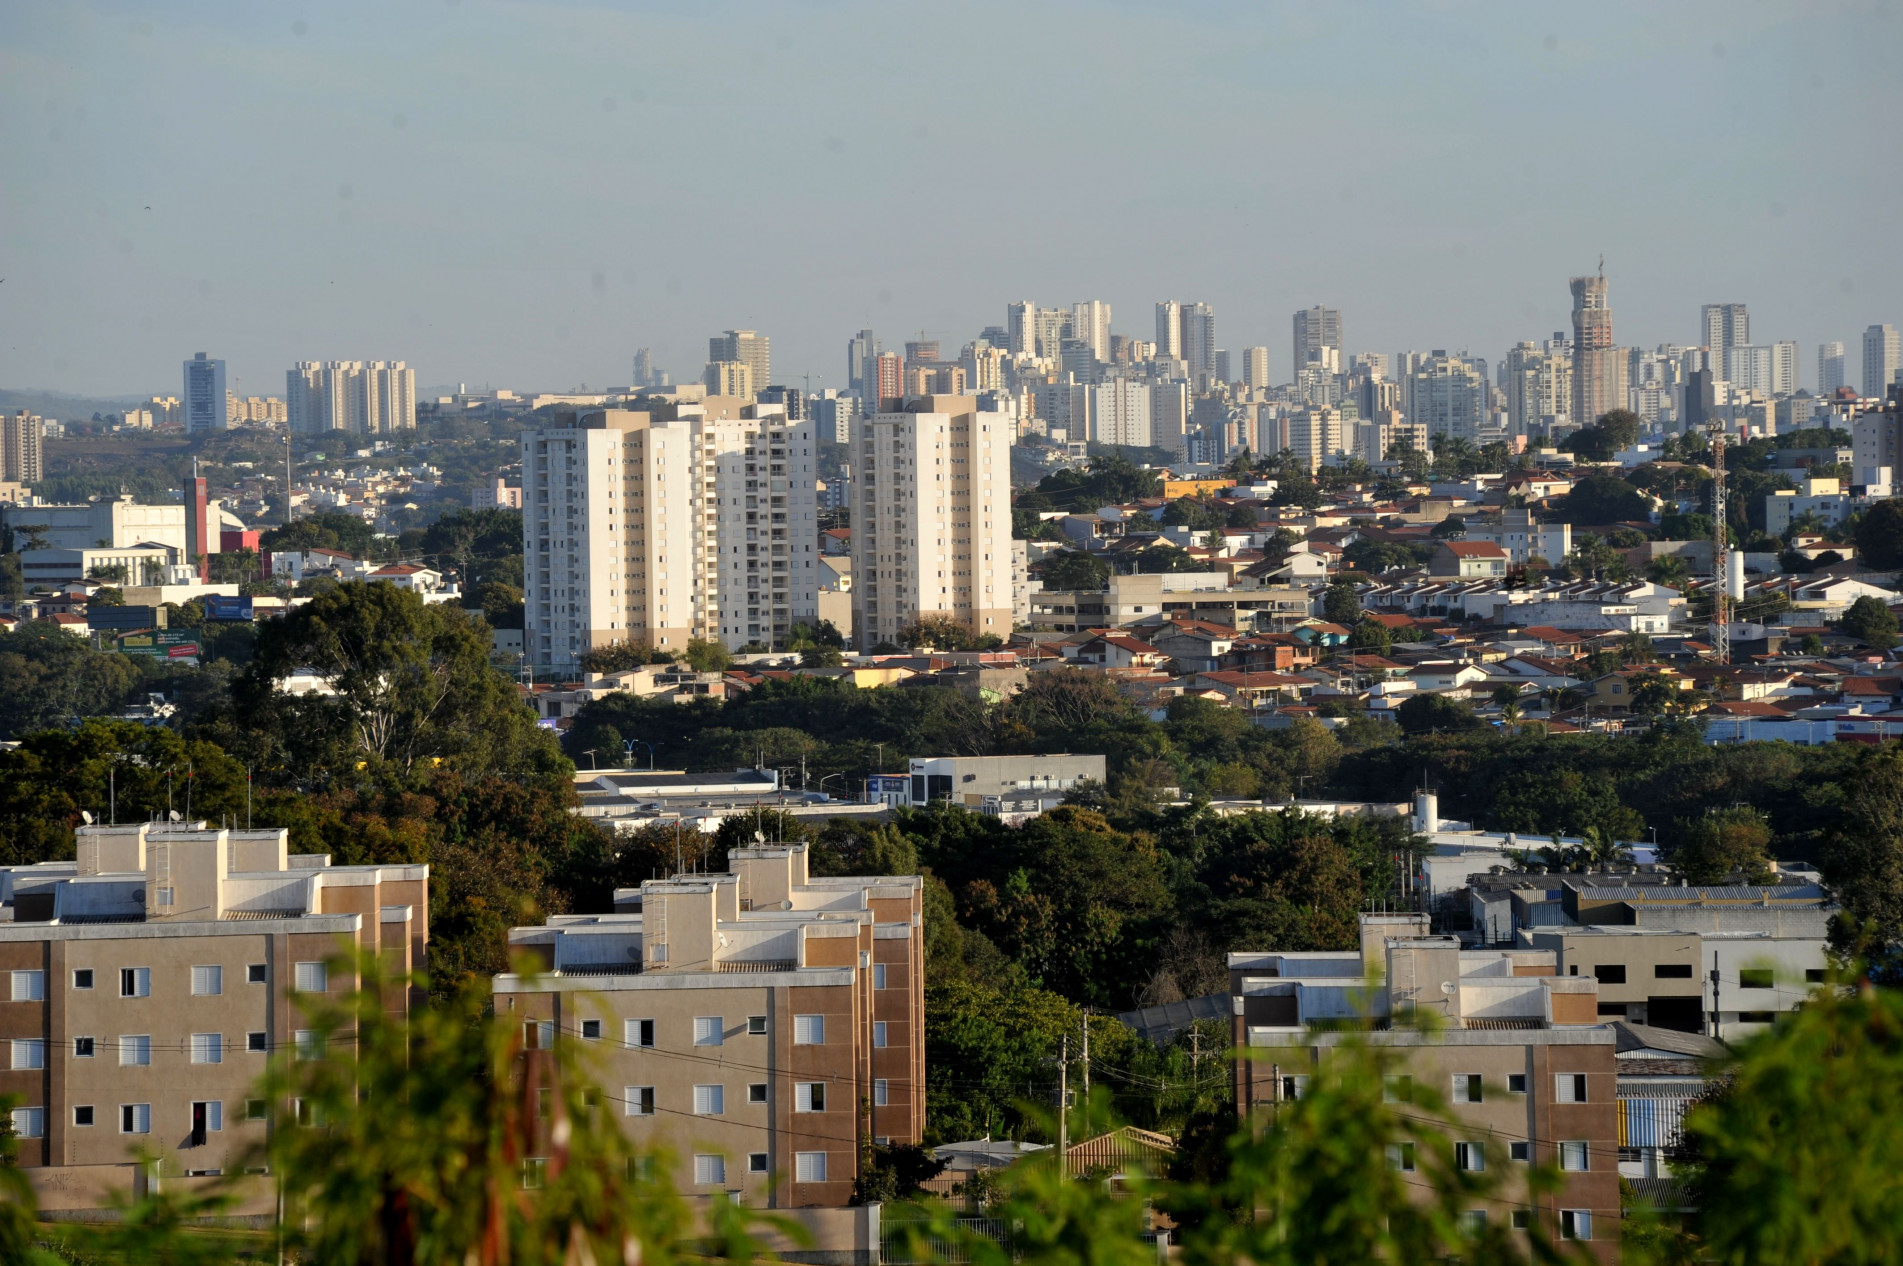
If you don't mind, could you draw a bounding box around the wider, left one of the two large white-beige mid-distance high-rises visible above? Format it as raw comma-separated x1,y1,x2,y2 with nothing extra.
521,396,818,670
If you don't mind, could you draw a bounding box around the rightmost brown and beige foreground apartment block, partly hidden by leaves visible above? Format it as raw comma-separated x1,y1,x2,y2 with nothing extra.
1229,916,1619,1262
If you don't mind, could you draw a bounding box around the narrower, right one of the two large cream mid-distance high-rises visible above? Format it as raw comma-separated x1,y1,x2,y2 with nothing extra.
853,396,1012,649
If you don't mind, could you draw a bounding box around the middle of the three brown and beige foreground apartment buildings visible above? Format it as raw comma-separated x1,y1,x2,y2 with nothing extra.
495,843,925,1209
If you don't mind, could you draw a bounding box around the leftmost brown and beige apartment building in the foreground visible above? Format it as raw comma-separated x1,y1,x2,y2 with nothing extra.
0,822,428,1213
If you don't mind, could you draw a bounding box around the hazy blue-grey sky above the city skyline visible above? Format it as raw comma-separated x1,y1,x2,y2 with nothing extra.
0,0,1903,394
